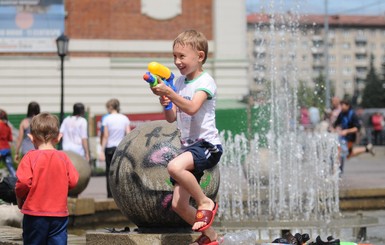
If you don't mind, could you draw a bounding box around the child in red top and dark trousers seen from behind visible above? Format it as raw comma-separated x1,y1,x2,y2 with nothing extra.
15,113,79,245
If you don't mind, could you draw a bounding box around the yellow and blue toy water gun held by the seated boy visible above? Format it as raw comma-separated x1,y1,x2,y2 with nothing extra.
143,62,176,110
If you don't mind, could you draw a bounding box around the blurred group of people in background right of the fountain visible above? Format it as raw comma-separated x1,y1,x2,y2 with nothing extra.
300,97,378,174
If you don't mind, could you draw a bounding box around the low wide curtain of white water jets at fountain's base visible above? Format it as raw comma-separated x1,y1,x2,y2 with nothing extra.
218,132,339,221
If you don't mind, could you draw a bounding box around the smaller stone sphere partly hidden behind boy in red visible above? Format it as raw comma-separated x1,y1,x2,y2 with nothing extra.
64,151,91,197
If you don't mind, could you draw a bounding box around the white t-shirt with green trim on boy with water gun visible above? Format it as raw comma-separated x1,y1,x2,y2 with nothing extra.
175,72,221,146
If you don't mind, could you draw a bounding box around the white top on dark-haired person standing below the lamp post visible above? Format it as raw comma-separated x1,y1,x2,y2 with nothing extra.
60,116,88,157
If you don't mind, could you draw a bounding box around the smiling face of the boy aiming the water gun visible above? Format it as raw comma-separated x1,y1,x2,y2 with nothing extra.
173,44,205,80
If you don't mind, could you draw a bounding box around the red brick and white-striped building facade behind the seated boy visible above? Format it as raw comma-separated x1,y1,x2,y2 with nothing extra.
0,0,249,116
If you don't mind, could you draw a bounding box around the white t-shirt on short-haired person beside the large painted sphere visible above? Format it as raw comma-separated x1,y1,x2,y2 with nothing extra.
102,113,130,148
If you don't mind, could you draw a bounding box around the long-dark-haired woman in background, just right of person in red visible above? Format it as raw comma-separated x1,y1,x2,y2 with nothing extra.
15,101,40,162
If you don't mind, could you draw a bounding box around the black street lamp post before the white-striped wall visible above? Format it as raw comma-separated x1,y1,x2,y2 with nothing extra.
56,34,69,124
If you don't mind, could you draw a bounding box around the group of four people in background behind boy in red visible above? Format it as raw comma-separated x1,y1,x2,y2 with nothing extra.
0,99,130,189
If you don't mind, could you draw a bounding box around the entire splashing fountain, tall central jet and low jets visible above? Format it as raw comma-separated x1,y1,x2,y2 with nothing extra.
218,1,339,226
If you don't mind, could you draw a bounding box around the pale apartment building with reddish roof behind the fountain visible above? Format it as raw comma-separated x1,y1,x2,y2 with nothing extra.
247,13,385,97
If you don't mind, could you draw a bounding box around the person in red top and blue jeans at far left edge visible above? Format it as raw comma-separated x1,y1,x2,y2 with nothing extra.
0,109,16,177
